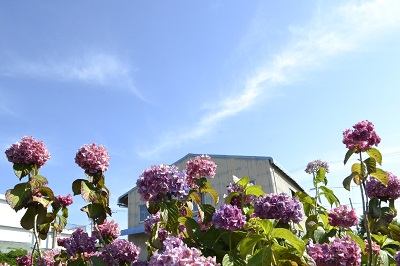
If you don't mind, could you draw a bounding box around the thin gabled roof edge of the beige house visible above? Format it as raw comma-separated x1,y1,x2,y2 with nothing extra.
117,153,304,207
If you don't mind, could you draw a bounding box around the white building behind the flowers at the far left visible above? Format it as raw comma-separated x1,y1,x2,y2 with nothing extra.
0,194,85,252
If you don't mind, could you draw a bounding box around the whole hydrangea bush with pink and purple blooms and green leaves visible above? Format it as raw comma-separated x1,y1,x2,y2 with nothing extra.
6,121,400,266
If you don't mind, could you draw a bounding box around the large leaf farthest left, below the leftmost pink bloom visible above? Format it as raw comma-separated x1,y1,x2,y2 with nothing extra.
5,183,32,212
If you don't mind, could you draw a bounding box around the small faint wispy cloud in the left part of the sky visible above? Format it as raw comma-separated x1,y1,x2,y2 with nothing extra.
3,53,144,100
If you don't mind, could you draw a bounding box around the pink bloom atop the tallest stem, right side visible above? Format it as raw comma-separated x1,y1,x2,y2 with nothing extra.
343,120,381,153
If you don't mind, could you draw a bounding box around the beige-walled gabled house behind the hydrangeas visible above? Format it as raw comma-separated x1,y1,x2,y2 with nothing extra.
118,153,304,258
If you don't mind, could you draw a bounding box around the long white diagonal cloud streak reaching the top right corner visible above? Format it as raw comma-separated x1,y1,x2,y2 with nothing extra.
139,0,400,157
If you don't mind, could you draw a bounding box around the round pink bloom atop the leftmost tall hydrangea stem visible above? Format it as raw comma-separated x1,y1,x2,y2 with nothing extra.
5,136,50,168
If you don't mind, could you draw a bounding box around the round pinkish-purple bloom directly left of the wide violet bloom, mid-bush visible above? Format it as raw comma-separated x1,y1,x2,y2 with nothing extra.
212,204,246,231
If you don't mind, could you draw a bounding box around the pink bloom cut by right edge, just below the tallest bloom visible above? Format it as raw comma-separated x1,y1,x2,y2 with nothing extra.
365,172,400,200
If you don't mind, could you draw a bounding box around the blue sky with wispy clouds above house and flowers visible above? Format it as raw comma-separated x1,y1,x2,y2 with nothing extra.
0,0,400,231
